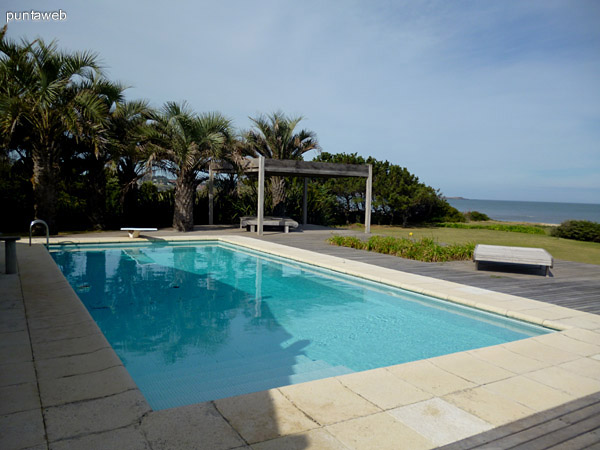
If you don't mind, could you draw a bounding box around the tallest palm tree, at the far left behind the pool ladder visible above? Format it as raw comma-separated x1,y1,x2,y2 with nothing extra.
0,27,107,232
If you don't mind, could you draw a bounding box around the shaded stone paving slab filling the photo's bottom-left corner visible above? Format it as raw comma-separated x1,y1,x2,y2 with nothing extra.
0,408,46,450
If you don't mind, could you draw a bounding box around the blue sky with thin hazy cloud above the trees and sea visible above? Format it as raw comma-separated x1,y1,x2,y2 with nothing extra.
1,0,600,204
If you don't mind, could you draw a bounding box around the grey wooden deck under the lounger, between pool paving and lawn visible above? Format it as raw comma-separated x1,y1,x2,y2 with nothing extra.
253,231,600,314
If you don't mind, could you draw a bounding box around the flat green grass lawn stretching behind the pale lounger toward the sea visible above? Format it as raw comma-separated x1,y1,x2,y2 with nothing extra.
346,225,600,265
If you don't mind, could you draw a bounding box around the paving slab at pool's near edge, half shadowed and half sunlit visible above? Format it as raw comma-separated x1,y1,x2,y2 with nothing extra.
214,389,319,444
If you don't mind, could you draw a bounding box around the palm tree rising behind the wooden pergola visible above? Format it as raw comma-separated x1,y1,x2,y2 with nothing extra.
245,111,320,215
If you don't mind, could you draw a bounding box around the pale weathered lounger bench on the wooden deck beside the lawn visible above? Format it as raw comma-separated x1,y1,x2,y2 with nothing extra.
473,244,554,276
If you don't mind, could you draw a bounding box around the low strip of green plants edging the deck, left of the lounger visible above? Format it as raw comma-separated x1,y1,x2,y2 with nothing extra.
329,236,475,262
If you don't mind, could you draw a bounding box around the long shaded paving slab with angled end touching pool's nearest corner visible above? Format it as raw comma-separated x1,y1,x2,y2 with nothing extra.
43,390,150,442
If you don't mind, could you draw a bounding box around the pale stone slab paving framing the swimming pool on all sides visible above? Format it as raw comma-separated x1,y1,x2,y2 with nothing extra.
0,235,600,449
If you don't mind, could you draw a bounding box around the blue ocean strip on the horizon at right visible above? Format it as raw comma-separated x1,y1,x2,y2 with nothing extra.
447,198,600,224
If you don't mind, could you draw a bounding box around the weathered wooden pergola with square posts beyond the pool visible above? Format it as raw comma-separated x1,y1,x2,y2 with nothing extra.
208,156,373,235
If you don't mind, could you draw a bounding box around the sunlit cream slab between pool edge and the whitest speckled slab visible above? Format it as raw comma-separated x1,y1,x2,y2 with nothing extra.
337,368,432,410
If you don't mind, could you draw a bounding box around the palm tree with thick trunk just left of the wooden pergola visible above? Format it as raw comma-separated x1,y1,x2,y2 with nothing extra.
148,102,231,231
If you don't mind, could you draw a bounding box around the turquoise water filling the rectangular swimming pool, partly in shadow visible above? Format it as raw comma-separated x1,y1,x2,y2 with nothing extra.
51,242,550,409
